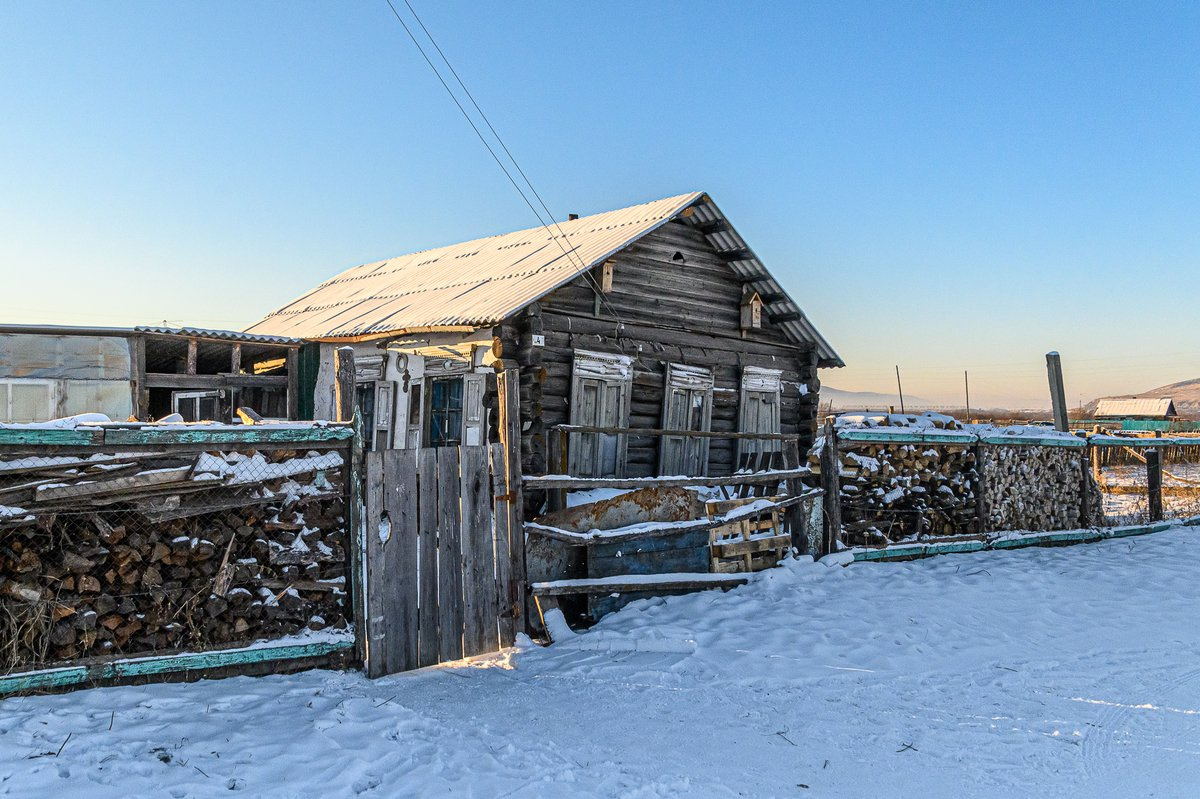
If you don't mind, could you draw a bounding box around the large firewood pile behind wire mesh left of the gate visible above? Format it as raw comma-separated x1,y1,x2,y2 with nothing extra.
0,450,348,672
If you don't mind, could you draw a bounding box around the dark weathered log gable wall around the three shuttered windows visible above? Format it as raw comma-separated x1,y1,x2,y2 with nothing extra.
494,221,820,484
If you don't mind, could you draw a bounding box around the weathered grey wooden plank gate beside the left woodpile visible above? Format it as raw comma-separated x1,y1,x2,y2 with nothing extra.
364,444,524,677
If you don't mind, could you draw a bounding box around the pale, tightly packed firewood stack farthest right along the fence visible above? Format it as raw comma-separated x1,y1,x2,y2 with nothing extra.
984,446,1103,530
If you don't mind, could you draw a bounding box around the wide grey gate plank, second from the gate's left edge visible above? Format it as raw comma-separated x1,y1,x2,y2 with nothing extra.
386,450,419,672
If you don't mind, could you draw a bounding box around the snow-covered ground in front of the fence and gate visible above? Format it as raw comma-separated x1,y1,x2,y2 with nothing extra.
0,529,1200,799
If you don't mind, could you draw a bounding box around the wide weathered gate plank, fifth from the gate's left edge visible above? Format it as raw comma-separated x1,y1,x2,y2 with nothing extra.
458,446,499,657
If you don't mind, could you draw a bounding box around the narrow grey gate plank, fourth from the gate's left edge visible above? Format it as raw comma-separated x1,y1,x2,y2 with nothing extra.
436,446,463,661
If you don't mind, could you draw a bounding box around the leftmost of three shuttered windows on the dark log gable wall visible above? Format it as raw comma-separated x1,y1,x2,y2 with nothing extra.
568,350,634,477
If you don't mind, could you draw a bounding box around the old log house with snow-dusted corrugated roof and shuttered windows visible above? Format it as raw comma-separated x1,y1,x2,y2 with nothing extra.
247,192,842,476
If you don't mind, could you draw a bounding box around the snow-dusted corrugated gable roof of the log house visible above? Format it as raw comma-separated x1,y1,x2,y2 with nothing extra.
246,192,844,366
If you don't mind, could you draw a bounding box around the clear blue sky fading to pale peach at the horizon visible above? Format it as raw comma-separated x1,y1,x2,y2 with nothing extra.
0,0,1200,404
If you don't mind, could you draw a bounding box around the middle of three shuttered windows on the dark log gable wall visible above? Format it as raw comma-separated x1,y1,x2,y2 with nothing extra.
659,364,713,476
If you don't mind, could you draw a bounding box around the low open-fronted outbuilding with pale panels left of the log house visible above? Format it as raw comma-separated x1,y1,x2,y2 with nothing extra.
0,325,301,423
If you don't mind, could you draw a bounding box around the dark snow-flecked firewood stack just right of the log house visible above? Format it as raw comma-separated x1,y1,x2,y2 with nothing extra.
810,443,977,546
